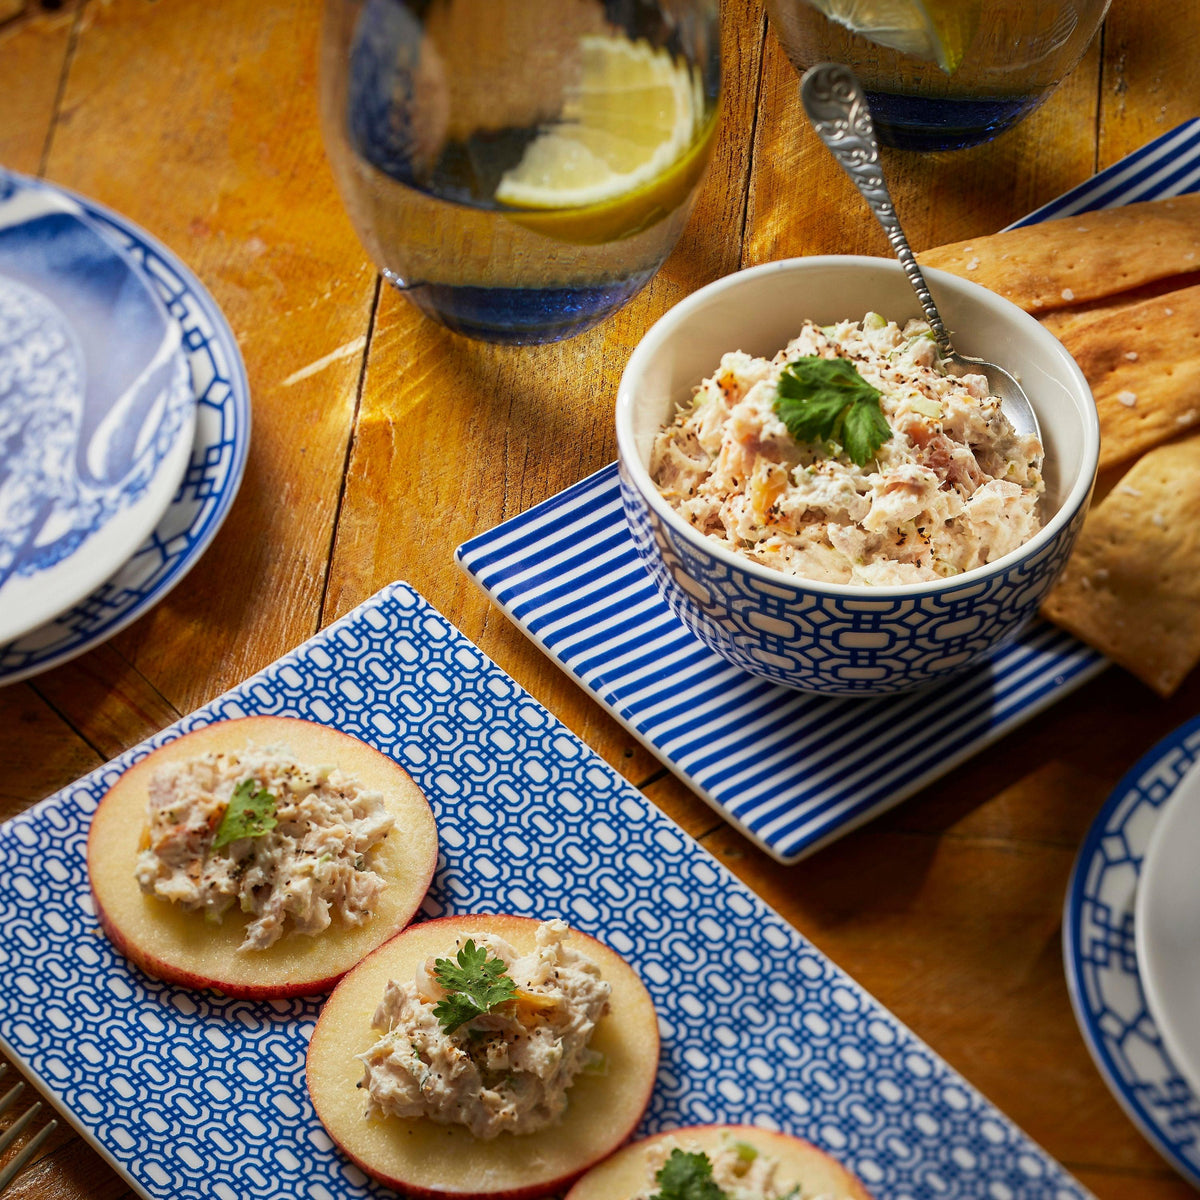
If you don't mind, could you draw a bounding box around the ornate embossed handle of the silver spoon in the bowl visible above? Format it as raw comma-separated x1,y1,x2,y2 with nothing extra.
800,62,952,354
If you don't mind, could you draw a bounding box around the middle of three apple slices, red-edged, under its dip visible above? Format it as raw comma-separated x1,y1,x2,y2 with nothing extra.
307,914,659,1200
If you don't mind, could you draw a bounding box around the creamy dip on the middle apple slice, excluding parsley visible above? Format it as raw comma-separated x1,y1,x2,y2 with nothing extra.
360,920,612,1138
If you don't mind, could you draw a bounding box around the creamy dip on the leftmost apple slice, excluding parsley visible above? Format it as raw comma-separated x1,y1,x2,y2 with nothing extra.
134,746,394,950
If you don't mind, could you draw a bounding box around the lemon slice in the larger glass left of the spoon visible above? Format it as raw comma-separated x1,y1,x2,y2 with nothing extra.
496,36,715,242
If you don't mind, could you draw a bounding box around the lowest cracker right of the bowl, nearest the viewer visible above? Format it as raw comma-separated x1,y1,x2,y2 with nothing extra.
1042,436,1200,696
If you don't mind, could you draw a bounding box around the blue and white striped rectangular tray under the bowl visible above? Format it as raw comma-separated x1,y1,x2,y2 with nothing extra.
458,120,1200,863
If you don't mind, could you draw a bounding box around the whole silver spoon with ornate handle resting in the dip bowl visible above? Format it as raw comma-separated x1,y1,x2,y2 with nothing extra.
800,62,1042,442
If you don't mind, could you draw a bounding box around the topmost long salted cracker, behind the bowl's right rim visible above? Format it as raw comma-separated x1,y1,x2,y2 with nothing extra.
917,194,1200,313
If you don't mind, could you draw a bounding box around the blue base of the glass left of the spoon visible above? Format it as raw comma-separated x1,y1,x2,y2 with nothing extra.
383,270,654,346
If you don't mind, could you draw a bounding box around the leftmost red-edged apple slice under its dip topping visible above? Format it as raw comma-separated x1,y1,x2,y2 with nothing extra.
88,716,438,1000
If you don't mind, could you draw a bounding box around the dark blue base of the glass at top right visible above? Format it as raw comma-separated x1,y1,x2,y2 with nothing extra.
866,91,1045,150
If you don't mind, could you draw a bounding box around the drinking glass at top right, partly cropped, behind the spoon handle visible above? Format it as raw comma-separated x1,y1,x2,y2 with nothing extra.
767,0,1109,150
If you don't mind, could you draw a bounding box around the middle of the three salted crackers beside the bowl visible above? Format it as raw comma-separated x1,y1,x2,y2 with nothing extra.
1058,284,1200,470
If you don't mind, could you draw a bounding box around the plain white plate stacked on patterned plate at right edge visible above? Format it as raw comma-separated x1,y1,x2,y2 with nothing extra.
1134,768,1200,1093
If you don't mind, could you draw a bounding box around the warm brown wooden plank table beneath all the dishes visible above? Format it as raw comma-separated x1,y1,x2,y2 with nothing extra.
0,0,1200,1200
